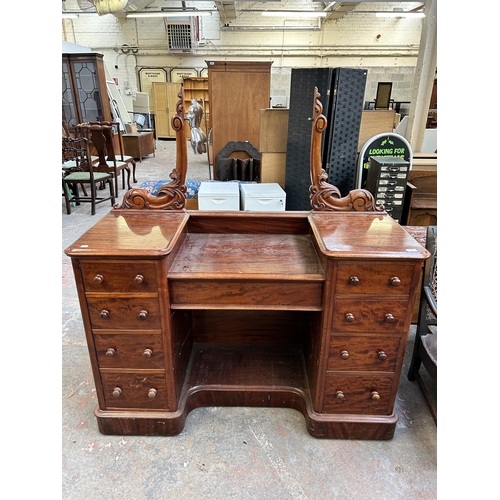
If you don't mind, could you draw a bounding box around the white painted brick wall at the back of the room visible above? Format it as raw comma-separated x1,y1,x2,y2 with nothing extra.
62,0,428,114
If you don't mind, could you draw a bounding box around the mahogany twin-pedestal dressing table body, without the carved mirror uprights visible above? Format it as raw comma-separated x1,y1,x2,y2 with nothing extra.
66,210,428,439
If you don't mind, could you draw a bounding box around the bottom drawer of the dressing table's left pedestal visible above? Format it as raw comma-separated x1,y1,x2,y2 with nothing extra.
101,371,168,410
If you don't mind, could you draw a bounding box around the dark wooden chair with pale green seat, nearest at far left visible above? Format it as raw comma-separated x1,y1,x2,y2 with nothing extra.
62,137,115,215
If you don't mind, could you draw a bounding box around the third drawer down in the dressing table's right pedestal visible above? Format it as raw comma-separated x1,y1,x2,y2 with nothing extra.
326,335,401,372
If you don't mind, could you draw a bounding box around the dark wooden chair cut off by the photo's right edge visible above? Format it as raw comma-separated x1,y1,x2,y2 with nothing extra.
408,226,437,423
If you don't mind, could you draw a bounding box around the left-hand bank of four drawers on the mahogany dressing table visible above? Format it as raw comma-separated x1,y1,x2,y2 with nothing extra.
80,259,171,410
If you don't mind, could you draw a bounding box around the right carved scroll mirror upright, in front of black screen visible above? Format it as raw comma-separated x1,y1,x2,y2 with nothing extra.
309,87,384,212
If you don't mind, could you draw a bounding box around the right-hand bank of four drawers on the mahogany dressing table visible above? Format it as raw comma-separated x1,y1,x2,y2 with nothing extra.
323,262,415,415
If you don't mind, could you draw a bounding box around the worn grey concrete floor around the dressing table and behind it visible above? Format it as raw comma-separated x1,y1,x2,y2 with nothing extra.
61,140,437,500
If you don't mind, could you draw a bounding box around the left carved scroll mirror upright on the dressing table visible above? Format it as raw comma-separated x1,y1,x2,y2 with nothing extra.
114,85,187,210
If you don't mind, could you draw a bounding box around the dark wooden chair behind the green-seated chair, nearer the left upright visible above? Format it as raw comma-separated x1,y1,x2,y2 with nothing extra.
87,124,132,195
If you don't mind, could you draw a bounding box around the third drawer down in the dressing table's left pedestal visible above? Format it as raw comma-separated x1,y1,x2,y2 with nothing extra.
94,334,165,370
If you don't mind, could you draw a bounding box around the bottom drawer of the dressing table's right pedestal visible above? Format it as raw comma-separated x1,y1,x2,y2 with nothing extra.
323,375,392,415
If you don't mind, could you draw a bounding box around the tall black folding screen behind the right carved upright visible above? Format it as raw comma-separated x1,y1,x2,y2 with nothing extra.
285,68,367,210
